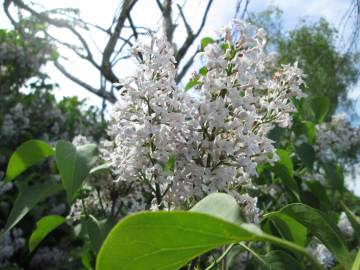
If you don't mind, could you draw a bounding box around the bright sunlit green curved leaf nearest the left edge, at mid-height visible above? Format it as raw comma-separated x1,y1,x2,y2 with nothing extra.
5,140,54,181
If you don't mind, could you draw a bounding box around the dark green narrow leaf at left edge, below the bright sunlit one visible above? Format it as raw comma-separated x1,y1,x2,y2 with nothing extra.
3,181,61,236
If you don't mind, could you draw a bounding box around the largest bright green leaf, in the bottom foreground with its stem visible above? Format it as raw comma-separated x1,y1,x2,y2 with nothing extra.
96,211,321,270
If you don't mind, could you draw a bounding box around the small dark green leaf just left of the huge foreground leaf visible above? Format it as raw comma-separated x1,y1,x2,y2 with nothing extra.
86,215,115,253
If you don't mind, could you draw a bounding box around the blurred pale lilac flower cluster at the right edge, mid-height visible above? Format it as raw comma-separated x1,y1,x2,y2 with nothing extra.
314,114,360,159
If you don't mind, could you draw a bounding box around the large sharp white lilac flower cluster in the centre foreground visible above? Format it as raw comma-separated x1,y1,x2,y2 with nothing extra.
105,21,303,213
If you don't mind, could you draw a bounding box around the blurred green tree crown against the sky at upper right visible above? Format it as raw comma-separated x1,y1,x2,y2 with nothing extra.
277,19,359,117
